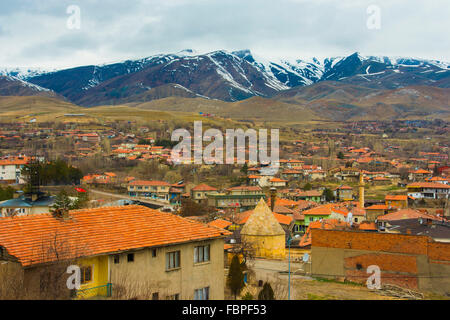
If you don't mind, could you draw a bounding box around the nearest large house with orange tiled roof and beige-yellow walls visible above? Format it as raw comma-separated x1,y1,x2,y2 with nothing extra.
0,205,230,300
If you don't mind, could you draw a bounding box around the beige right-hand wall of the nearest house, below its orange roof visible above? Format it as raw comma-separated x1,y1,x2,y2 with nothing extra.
109,239,224,300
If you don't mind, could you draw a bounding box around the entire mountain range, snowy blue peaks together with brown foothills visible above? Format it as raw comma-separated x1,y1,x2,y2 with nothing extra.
0,50,450,120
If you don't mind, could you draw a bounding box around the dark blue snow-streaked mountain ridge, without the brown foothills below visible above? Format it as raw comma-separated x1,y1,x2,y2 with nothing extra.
4,49,450,106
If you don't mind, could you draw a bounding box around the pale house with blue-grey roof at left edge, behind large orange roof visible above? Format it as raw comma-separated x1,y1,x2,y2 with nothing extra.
0,192,55,217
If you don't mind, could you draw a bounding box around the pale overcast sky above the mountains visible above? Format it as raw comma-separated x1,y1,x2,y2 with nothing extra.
0,0,450,69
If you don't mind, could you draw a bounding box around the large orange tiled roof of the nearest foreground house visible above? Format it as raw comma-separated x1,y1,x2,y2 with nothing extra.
0,205,230,266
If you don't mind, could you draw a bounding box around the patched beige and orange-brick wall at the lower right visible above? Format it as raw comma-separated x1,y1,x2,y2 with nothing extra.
311,229,450,294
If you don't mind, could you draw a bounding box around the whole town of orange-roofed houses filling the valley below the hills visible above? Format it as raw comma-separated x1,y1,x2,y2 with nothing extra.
0,115,450,300
